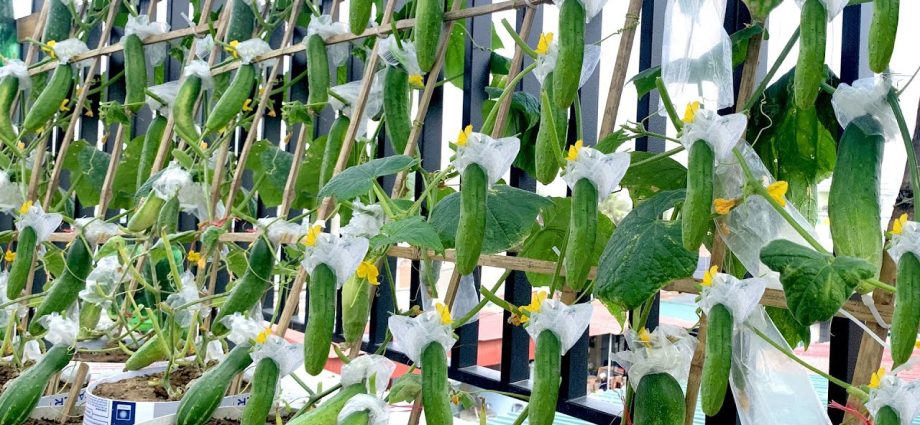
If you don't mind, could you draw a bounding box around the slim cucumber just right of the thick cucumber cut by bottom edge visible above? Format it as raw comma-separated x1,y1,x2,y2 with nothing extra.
700,304,734,416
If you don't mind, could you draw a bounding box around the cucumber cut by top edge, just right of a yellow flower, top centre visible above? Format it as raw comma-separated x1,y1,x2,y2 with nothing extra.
553,0,585,109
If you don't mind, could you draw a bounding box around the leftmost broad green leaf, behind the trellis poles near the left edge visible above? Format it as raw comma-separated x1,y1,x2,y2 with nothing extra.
63,140,111,207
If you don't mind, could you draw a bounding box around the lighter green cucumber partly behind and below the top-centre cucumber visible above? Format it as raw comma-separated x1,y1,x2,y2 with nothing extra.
534,72,568,184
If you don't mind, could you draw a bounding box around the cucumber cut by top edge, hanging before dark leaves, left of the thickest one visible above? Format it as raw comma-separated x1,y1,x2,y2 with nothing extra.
793,0,827,110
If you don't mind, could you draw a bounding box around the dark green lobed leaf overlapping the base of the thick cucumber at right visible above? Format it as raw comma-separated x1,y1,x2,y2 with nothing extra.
760,239,875,325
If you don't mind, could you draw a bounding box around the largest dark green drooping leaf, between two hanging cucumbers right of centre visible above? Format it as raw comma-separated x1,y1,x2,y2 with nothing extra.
595,190,697,312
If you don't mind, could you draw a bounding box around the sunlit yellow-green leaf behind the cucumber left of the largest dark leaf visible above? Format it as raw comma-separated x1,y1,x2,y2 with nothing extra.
520,198,614,286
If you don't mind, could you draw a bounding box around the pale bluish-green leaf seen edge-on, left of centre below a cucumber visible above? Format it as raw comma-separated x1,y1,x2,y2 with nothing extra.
319,155,416,201
